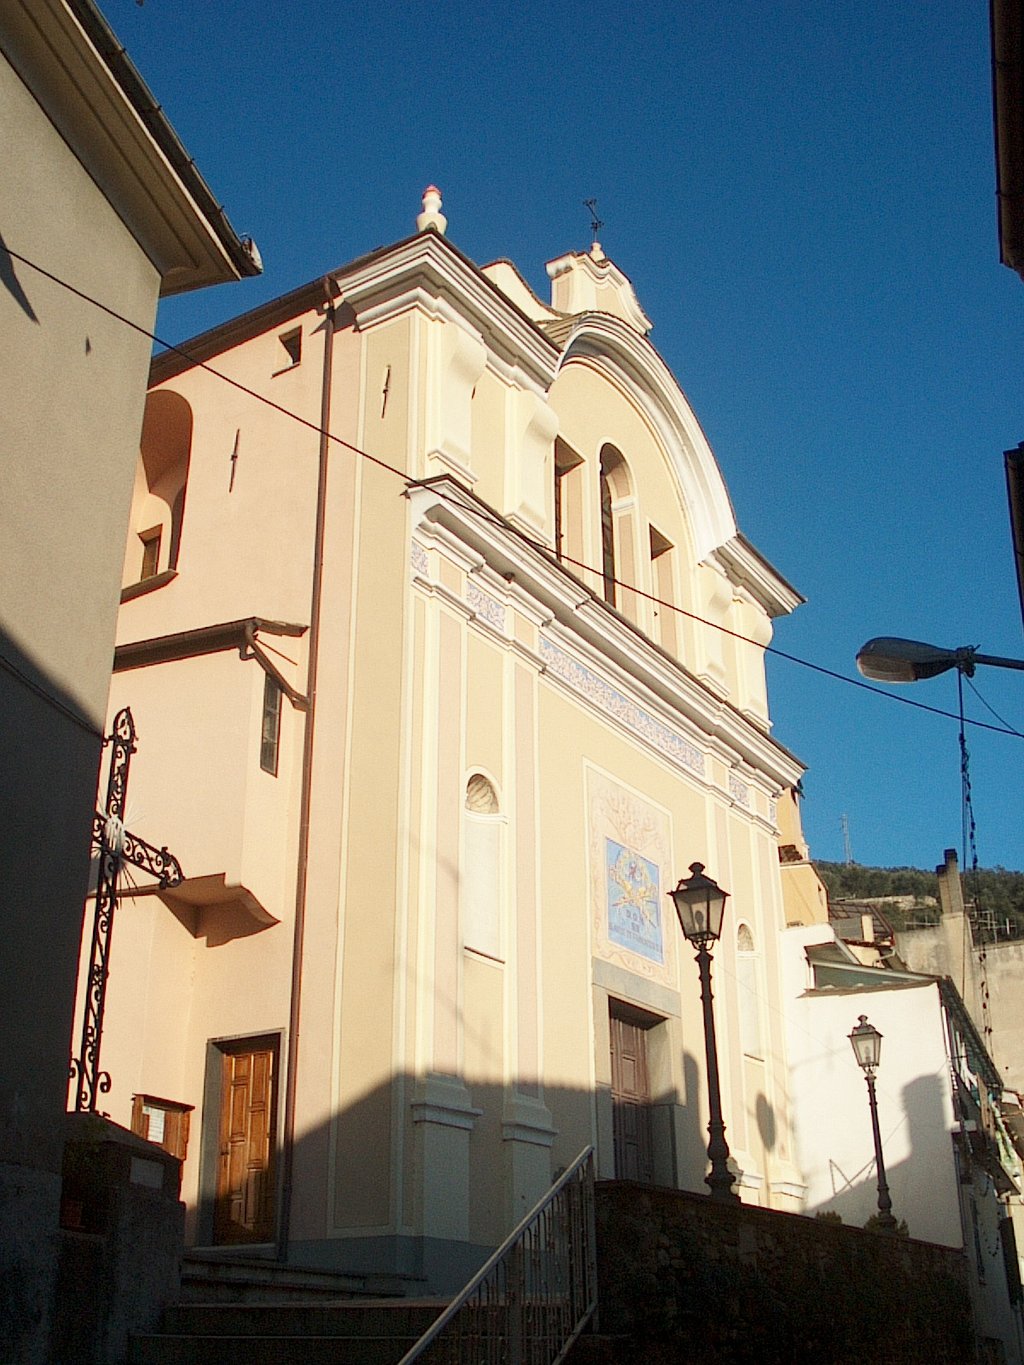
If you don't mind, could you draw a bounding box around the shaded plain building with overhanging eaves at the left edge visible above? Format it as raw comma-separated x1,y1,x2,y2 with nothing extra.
0,0,258,1361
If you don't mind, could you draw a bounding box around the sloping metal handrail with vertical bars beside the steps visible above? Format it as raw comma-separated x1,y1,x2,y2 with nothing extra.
399,1147,597,1365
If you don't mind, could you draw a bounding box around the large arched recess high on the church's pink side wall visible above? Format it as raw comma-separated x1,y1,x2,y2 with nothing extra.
124,389,193,583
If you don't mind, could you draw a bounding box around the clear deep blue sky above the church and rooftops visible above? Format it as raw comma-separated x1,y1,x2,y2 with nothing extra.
101,0,1024,868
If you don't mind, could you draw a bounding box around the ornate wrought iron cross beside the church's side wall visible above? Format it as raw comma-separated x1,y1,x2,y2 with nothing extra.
71,706,183,1114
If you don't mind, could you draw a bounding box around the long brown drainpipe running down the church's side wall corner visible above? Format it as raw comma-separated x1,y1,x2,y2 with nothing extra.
277,277,336,1261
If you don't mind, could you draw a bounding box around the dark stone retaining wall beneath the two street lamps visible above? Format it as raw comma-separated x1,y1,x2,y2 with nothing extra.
597,1181,976,1365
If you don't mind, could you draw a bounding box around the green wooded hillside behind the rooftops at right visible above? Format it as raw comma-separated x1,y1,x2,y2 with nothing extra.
814,863,1024,939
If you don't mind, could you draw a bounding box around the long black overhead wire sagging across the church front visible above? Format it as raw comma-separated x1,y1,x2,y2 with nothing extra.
13,246,1024,738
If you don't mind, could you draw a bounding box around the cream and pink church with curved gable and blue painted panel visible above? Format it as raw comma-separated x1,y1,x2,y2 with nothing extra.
86,191,804,1289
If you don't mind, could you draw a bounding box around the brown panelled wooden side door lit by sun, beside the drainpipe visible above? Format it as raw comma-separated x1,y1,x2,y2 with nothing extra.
213,1039,277,1245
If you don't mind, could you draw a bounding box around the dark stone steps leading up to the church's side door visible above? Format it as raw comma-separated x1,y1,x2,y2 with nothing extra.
128,1254,445,1365
